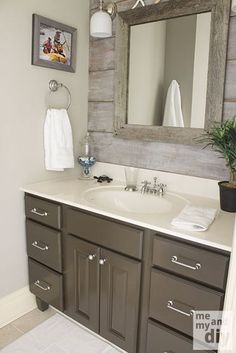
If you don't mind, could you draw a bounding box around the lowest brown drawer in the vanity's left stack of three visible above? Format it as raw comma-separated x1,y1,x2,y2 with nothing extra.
29,259,63,310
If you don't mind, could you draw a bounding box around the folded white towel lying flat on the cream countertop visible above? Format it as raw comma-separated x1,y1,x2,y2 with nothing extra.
171,205,217,232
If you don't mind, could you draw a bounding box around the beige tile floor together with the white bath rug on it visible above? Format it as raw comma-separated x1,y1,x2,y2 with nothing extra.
0,309,121,353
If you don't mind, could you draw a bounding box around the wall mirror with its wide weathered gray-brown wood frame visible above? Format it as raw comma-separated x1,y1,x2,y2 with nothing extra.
114,0,231,144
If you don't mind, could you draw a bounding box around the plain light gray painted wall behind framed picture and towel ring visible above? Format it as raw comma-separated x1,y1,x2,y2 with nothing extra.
0,0,89,296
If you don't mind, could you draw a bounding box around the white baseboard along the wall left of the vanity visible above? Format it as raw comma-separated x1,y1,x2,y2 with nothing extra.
0,286,36,328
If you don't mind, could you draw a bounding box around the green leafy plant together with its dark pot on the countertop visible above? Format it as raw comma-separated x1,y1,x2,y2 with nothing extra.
198,116,236,212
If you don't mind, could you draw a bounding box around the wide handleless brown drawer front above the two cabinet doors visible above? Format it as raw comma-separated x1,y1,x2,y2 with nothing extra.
66,207,143,259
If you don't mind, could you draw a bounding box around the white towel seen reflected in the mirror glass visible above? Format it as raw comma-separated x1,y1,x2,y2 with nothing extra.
162,80,184,127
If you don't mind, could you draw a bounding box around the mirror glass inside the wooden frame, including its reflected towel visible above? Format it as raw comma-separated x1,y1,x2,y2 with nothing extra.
127,12,211,128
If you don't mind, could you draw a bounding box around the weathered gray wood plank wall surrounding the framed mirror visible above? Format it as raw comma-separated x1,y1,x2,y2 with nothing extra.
88,0,236,180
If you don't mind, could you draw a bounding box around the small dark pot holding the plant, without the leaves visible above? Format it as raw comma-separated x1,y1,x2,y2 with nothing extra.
218,181,236,212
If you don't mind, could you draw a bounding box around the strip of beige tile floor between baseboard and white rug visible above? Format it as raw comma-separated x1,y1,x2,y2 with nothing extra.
0,308,55,350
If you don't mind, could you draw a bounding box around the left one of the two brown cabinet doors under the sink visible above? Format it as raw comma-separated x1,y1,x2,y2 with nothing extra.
64,235,99,332
